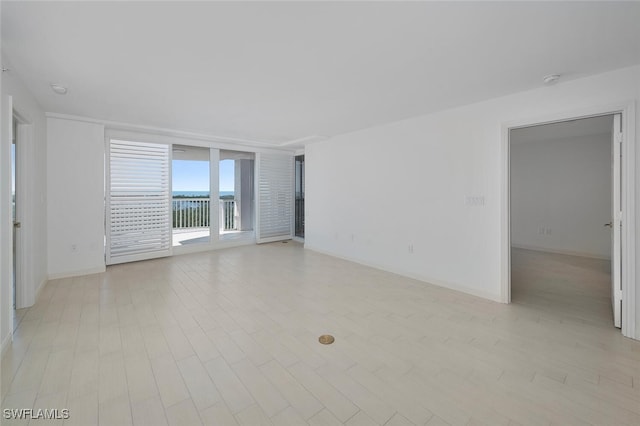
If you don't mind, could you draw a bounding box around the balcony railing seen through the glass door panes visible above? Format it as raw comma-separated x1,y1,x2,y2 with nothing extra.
172,198,237,231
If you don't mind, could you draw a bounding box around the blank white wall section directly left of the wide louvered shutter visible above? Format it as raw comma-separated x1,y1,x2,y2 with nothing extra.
47,117,105,278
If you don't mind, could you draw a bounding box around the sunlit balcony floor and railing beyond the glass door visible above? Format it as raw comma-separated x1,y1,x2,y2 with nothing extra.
172,197,238,246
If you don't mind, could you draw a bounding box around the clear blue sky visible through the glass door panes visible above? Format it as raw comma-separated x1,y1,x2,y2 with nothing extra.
172,160,235,191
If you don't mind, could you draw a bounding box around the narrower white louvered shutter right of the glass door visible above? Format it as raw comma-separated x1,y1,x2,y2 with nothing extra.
256,153,294,243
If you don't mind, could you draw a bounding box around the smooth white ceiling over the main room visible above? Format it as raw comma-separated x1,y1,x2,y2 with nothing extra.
1,1,640,144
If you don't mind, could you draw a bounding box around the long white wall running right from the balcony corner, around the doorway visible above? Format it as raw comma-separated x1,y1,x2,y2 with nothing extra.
305,66,640,330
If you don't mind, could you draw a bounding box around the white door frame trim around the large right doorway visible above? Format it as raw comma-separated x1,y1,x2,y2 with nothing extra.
500,101,640,338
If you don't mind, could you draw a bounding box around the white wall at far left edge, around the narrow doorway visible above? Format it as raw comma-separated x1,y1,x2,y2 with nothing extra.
0,59,47,352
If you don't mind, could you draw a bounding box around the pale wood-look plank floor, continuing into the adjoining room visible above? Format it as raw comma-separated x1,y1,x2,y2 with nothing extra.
2,242,640,426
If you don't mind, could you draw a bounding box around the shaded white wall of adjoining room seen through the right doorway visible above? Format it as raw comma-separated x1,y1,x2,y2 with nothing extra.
511,130,611,259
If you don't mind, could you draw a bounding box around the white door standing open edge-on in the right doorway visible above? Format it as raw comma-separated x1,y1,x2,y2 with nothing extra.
610,114,622,328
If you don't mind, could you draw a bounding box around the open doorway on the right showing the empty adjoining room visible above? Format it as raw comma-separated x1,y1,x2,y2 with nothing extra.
509,114,621,327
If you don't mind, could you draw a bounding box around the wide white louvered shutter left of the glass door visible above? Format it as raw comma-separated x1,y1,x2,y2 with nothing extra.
107,140,172,265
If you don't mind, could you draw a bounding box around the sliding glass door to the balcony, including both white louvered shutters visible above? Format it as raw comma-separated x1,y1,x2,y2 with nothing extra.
105,136,292,265
